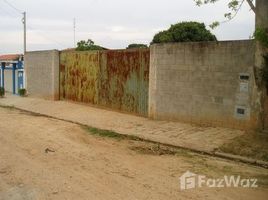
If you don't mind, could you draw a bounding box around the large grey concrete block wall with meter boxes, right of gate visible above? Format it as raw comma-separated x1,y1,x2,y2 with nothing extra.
149,40,258,129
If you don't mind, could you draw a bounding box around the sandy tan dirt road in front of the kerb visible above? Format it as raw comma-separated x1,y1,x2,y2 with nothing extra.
0,108,268,200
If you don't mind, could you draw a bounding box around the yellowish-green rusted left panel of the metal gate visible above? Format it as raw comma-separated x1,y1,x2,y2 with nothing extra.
60,52,99,104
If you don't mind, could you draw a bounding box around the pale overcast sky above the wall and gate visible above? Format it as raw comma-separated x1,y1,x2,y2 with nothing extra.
0,0,254,54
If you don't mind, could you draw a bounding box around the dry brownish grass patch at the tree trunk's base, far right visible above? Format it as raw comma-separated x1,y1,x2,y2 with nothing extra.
219,132,268,161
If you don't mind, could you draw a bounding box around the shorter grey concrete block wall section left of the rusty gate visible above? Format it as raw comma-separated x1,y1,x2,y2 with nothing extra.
24,50,59,100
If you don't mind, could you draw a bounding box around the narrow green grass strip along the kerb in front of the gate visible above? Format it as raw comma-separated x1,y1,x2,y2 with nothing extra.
82,126,142,141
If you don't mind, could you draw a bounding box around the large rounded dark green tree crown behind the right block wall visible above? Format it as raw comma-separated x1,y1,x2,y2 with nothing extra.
152,22,217,43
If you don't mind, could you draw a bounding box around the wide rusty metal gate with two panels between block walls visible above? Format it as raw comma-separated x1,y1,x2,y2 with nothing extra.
60,49,150,116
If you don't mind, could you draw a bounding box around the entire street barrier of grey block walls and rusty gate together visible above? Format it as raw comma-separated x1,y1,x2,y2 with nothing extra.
25,40,267,129
